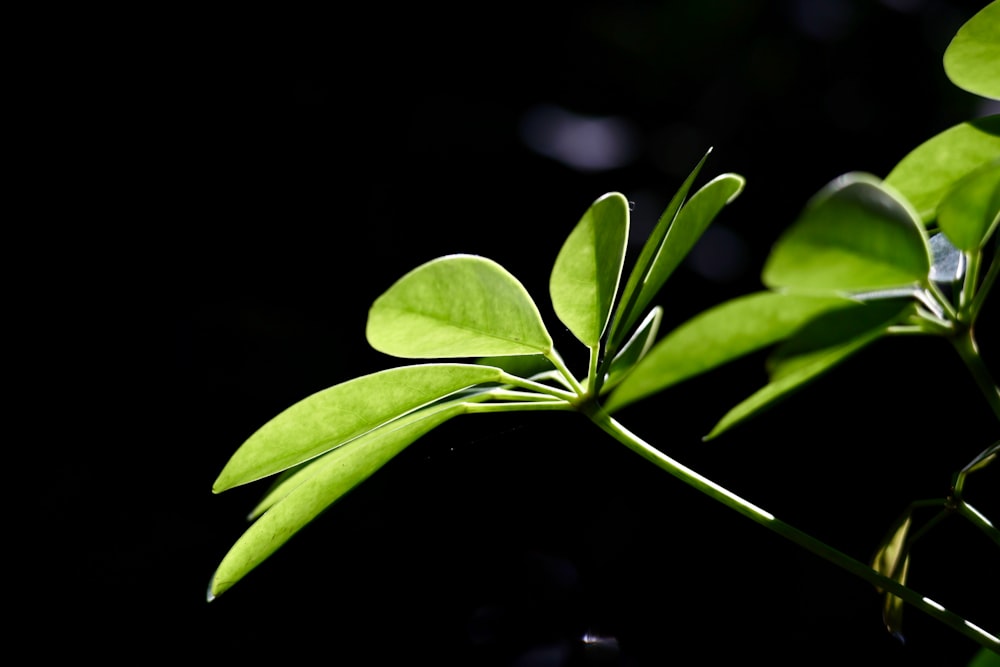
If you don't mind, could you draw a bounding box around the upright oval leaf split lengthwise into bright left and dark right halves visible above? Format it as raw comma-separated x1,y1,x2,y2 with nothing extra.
549,192,629,348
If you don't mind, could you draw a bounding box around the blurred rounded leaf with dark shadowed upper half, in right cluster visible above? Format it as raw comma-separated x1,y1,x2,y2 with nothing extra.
762,173,931,294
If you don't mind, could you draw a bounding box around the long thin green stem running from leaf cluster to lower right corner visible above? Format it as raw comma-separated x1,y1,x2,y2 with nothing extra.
587,405,1000,651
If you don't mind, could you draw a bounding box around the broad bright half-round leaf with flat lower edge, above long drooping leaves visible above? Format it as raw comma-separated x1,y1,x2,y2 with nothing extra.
366,255,552,358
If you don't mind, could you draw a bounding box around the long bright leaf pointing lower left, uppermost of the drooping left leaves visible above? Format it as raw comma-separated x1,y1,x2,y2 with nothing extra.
213,364,503,493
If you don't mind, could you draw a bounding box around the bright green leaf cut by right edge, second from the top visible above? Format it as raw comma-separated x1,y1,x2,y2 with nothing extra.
885,114,1000,223
